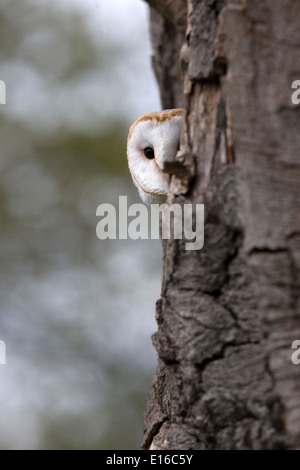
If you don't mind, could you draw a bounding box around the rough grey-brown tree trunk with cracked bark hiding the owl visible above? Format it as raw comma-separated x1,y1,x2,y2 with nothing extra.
143,0,300,449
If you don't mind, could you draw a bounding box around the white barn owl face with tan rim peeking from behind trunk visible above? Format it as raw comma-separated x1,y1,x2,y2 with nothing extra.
127,109,182,204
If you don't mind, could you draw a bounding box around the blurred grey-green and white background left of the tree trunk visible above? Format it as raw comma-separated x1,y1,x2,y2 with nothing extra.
0,0,162,450
